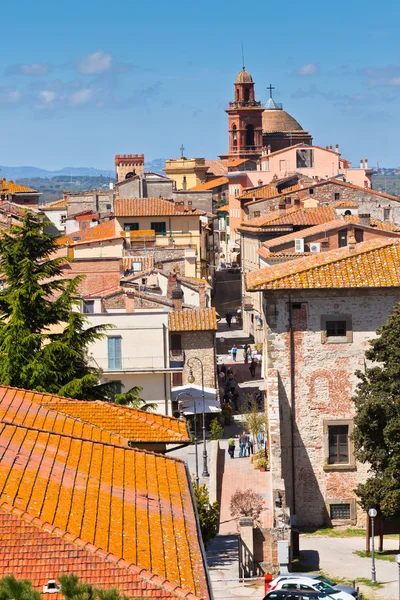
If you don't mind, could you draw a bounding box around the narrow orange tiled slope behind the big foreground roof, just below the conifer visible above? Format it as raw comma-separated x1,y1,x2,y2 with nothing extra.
0,386,190,444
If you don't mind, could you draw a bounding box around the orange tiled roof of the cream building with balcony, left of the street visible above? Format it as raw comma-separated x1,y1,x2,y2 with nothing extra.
115,198,204,217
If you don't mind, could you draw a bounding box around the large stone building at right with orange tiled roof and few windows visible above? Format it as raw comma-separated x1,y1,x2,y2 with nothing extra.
247,237,400,527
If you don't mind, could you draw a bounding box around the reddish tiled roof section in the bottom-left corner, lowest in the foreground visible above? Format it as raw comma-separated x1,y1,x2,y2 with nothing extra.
0,504,194,600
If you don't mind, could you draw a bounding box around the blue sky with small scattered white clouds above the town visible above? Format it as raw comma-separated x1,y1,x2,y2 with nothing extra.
0,0,400,169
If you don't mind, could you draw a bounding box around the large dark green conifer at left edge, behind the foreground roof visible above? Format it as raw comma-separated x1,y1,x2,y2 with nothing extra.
0,212,110,400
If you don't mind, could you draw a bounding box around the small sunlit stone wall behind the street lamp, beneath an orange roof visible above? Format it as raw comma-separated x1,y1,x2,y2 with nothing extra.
181,331,217,388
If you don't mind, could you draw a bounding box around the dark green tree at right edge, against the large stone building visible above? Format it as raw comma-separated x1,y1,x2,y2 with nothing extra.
353,304,400,517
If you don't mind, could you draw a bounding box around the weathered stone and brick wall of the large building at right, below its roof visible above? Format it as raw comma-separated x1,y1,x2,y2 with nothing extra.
264,289,400,527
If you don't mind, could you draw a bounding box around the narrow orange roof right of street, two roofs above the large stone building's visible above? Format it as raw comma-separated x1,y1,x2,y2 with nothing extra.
240,205,337,231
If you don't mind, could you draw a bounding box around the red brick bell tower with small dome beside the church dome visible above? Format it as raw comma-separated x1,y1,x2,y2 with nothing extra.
220,67,264,159
